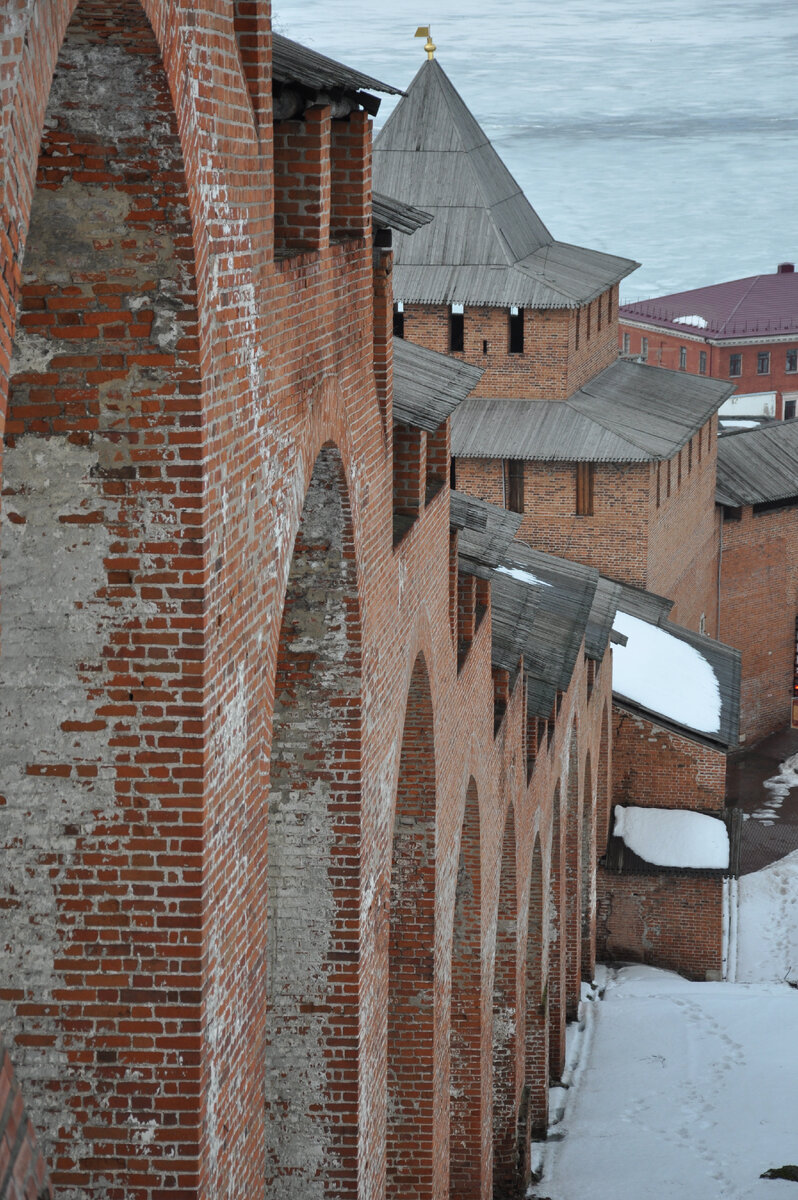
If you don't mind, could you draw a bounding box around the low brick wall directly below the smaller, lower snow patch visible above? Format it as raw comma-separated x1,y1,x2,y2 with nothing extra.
596,866,724,979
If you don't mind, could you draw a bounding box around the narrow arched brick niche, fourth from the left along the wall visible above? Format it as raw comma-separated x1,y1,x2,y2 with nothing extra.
449,779,482,1200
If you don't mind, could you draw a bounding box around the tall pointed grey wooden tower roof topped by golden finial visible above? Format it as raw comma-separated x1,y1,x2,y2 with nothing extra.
374,60,638,308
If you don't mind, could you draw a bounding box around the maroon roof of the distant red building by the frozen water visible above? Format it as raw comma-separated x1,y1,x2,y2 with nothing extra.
618,263,798,341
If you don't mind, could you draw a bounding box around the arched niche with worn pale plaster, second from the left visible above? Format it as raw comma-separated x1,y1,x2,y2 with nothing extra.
265,445,361,1200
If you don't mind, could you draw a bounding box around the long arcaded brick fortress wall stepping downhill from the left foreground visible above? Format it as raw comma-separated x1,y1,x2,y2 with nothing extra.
0,0,611,1200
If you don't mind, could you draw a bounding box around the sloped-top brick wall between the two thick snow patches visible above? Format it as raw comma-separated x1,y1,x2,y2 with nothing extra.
609,704,726,811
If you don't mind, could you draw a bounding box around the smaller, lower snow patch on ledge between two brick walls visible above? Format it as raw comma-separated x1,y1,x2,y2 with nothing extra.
612,806,728,870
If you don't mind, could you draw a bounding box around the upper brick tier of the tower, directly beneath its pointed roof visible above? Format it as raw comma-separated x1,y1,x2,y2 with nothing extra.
404,287,618,400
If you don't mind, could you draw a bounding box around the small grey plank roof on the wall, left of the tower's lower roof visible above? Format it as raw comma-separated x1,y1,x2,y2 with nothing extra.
394,337,482,433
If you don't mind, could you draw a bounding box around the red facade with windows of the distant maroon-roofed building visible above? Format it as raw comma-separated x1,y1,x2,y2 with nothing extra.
618,320,798,419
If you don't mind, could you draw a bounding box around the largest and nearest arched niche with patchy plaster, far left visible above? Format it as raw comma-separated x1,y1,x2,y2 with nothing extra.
0,0,204,1194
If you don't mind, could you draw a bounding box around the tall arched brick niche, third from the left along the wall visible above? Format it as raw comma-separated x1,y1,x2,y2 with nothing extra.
386,654,436,1200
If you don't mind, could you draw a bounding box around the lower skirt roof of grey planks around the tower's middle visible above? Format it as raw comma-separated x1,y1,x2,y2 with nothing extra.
451,359,733,462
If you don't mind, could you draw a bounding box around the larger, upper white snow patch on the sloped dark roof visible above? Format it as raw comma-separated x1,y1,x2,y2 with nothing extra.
612,612,721,733
